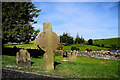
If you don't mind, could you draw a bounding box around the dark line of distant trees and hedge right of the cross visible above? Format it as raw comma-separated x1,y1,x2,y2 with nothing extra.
60,32,119,50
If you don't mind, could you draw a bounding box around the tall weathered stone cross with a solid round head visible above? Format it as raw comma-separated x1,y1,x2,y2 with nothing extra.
36,23,60,71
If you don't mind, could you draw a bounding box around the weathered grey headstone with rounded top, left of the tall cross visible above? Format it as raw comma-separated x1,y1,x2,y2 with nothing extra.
16,49,31,67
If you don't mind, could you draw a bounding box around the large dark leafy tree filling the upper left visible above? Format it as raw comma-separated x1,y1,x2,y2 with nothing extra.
2,2,41,43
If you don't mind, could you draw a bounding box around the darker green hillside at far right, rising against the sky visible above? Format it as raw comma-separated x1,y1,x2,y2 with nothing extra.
94,38,120,47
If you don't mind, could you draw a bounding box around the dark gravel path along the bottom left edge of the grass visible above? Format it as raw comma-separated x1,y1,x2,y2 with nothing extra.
2,69,65,80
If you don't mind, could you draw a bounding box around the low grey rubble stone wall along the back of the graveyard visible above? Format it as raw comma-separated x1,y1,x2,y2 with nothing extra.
56,50,120,60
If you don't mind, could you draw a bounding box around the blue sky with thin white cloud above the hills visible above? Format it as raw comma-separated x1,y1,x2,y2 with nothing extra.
33,2,118,40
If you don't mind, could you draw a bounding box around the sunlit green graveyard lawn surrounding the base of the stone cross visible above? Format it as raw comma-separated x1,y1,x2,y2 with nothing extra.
2,55,120,78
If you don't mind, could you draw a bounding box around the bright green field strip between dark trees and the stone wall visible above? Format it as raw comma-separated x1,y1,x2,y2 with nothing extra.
63,44,109,51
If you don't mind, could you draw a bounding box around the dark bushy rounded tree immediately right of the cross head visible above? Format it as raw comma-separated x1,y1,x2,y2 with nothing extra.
60,32,73,45
